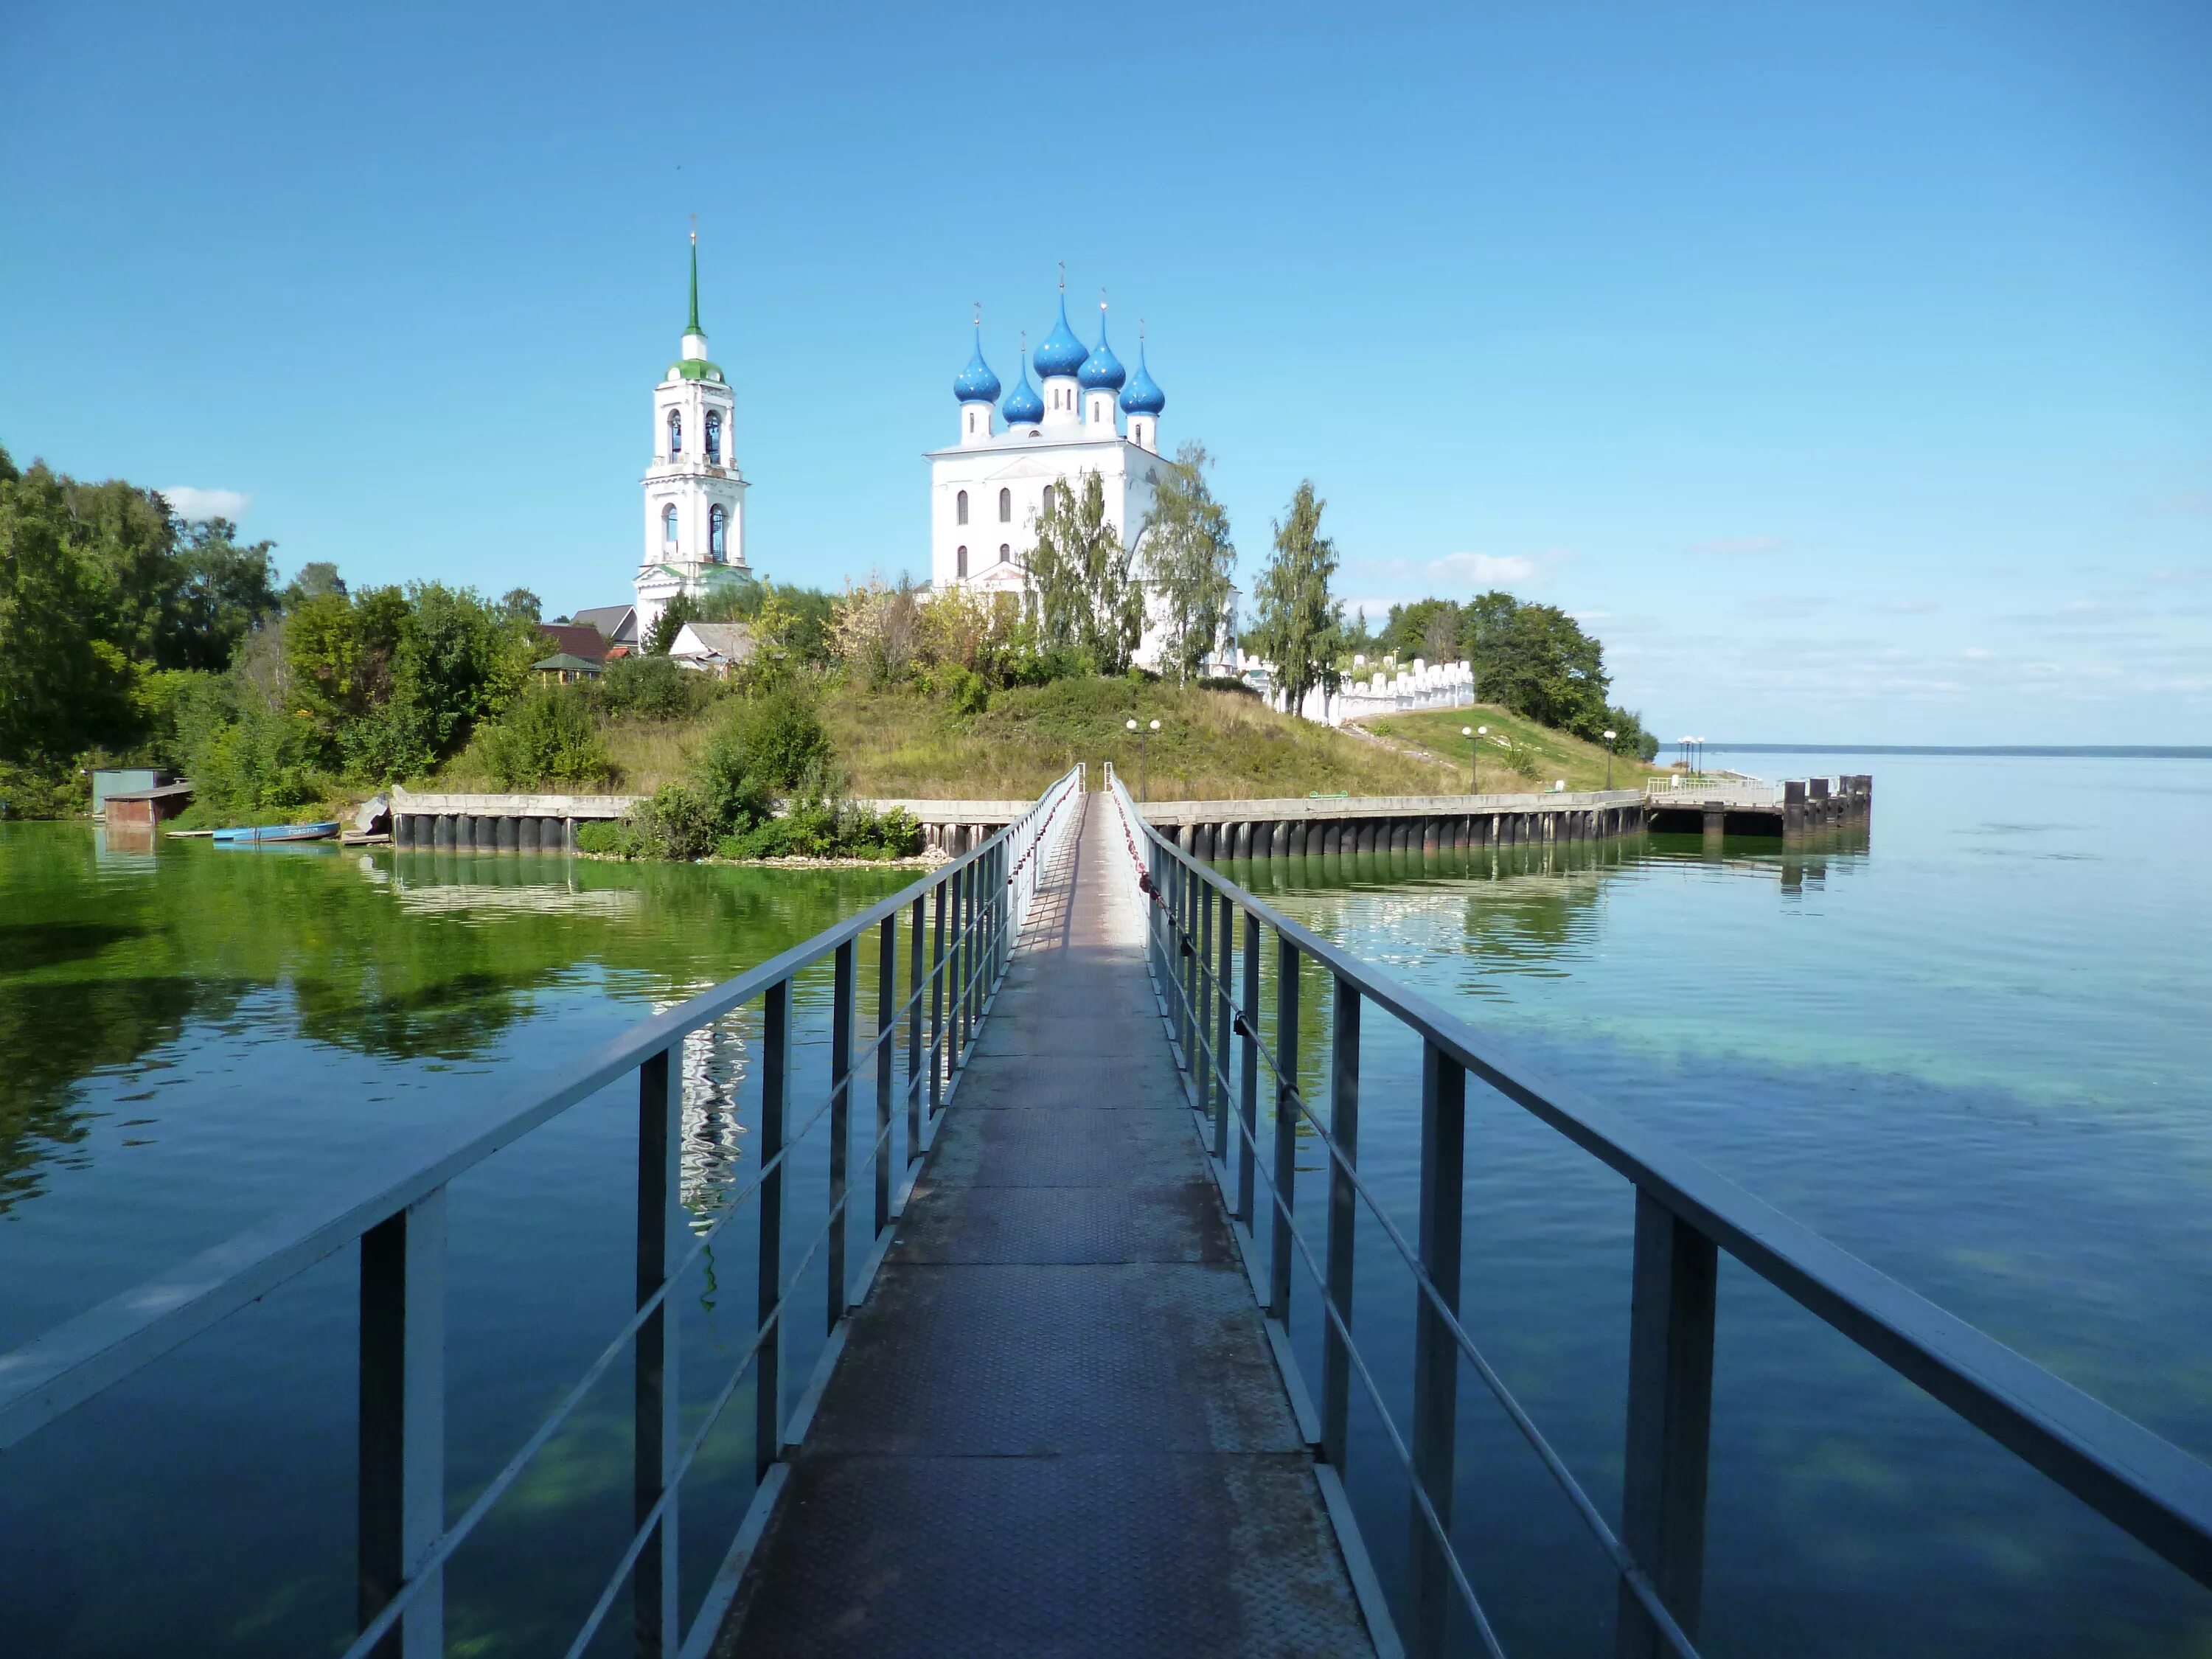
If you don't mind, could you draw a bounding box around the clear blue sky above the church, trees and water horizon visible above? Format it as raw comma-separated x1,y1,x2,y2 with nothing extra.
0,0,2212,743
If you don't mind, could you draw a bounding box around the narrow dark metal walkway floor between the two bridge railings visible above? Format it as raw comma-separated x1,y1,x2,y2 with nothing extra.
717,796,1374,1659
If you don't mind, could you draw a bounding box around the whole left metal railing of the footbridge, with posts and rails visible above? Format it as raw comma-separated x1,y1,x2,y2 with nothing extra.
0,765,1084,1659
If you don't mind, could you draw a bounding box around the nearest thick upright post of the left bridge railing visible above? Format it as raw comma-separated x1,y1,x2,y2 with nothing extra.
354,1188,445,1659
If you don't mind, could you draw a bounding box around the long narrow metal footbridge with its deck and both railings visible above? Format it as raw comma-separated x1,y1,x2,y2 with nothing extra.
0,770,2212,1659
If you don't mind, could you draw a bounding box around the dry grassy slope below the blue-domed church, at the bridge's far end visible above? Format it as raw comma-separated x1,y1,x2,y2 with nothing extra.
823,679,1464,801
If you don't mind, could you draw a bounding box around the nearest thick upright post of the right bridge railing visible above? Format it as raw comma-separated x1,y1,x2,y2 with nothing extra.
1615,1188,1719,1659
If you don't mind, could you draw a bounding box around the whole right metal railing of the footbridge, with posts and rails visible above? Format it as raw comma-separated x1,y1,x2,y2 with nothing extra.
1106,768,2212,1659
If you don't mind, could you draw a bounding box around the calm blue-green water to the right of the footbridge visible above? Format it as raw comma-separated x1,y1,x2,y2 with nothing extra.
1230,754,2212,1655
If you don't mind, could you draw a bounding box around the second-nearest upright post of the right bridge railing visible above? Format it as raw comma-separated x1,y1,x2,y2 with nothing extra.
1411,1042,1467,1659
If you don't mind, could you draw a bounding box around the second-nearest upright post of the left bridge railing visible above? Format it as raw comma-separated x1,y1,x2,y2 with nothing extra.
630,1037,684,1655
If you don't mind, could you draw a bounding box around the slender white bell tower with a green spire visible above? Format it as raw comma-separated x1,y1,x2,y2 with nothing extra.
633,232,745,639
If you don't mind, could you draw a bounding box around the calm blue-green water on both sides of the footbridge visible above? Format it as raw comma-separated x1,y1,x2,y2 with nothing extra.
0,757,2212,1657
